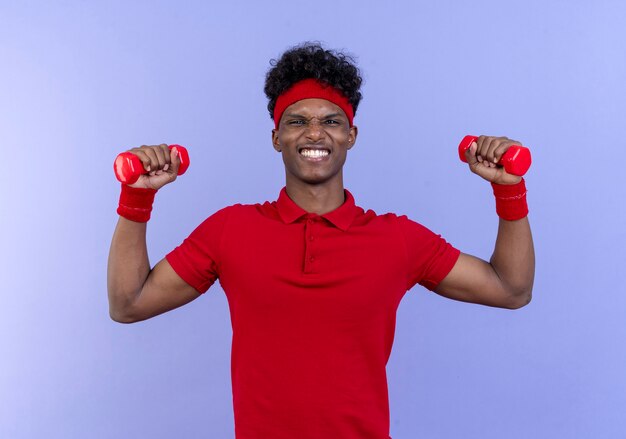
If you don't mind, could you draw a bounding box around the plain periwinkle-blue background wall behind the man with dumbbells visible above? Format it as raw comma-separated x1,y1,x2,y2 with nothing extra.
0,0,626,439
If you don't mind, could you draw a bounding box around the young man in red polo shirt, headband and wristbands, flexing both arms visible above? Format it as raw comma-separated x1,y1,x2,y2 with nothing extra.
108,44,534,439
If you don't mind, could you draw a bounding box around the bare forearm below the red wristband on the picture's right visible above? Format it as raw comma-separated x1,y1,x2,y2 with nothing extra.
490,217,535,301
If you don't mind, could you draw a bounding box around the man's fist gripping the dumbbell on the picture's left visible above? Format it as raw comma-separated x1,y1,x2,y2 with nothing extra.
127,143,180,190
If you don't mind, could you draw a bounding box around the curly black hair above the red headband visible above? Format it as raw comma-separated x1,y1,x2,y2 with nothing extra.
264,42,363,119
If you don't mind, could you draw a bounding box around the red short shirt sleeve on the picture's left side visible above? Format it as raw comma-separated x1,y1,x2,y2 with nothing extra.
165,208,229,294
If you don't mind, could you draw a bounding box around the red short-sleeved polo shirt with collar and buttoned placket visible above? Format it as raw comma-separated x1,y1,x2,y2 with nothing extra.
166,188,459,439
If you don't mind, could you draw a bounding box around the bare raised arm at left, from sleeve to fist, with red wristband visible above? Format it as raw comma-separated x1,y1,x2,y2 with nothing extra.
107,145,199,323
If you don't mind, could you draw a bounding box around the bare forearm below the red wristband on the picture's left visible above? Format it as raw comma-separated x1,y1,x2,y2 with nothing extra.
107,217,150,321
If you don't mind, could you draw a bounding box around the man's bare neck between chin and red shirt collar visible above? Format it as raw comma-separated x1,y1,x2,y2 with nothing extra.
286,179,345,215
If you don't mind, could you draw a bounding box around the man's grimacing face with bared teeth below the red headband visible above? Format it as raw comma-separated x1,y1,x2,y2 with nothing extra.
272,99,357,185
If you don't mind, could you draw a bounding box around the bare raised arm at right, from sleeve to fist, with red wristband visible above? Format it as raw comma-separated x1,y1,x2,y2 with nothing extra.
435,136,535,309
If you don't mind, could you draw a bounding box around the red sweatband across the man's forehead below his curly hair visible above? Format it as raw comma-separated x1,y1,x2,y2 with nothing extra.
274,78,354,129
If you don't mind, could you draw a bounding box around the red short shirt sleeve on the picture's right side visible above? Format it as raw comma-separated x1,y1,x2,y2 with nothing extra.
398,216,461,291
